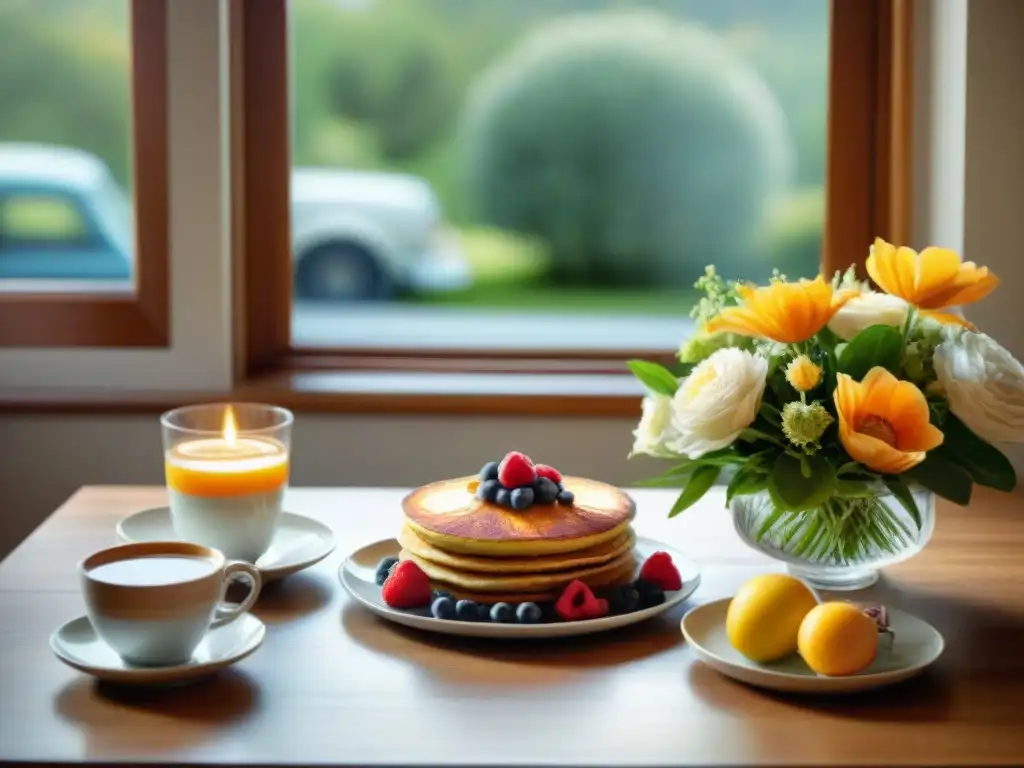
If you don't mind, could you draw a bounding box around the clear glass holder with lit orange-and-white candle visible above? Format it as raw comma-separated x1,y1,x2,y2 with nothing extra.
160,402,295,562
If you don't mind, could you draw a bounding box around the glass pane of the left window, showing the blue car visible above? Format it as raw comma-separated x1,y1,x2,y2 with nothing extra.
0,0,134,292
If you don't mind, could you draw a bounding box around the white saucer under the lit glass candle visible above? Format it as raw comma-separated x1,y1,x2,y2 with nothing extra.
117,507,334,583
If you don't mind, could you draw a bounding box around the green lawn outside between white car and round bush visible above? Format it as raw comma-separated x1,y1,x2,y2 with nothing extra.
404,229,698,316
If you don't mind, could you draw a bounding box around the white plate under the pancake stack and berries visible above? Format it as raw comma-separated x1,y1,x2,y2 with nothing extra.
338,537,700,638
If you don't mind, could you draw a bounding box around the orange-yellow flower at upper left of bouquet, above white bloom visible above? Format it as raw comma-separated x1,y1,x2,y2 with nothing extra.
706,275,857,344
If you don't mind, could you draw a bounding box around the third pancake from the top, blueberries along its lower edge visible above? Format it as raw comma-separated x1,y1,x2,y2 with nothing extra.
398,550,636,602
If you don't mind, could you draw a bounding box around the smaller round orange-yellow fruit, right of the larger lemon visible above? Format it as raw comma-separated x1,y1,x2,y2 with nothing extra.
797,602,879,677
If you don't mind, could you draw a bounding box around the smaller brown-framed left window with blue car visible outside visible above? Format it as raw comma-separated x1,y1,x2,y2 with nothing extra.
0,0,169,347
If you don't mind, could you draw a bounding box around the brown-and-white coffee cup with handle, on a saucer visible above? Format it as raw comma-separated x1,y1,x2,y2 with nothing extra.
79,542,261,667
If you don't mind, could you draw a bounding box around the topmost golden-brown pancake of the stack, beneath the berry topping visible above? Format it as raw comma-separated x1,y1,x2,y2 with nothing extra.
401,477,636,557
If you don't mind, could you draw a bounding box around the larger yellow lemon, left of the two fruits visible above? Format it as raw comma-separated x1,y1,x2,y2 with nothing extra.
725,573,817,664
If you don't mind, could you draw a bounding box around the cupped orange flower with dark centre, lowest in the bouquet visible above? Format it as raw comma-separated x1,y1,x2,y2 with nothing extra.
835,368,943,475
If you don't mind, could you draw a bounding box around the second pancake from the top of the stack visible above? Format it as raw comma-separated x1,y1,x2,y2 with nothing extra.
398,525,636,574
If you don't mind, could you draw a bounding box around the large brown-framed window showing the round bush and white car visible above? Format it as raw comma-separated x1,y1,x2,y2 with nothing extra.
239,0,909,397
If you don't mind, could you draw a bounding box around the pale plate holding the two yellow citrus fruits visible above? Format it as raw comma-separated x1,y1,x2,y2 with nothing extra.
682,598,944,694
